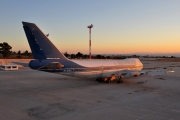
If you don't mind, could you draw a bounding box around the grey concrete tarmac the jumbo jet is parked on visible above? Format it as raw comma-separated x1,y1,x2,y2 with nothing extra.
0,59,180,120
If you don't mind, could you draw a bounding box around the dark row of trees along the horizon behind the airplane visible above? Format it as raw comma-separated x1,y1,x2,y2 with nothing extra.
0,42,175,59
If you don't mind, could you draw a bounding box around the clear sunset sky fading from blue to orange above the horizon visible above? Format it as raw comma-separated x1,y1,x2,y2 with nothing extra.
0,0,180,54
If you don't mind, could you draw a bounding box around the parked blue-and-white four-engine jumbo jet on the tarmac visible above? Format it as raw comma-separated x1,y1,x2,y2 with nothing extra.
22,22,174,83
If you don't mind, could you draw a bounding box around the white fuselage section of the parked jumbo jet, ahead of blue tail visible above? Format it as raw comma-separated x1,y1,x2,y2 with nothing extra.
60,58,143,78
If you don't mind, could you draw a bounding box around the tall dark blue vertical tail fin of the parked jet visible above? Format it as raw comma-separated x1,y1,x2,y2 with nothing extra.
22,22,67,60
